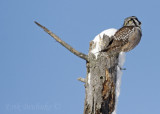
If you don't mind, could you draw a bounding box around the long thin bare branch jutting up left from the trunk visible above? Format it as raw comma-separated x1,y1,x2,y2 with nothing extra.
35,21,88,61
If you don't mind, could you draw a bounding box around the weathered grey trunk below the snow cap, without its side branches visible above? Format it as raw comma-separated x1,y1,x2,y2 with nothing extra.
84,38,119,114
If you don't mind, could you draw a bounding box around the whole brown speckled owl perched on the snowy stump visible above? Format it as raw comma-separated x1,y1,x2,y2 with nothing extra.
107,16,142,53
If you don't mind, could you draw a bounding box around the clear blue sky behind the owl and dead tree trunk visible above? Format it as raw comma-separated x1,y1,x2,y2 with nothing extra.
0,0,160,114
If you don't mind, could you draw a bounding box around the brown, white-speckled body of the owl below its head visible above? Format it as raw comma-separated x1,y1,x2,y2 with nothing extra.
108,26,141,53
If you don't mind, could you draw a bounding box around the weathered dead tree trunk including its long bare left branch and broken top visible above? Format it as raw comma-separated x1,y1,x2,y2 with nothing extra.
35,22,119,114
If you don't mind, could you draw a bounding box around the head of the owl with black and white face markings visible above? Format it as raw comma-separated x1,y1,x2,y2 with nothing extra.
123,16,141,27
